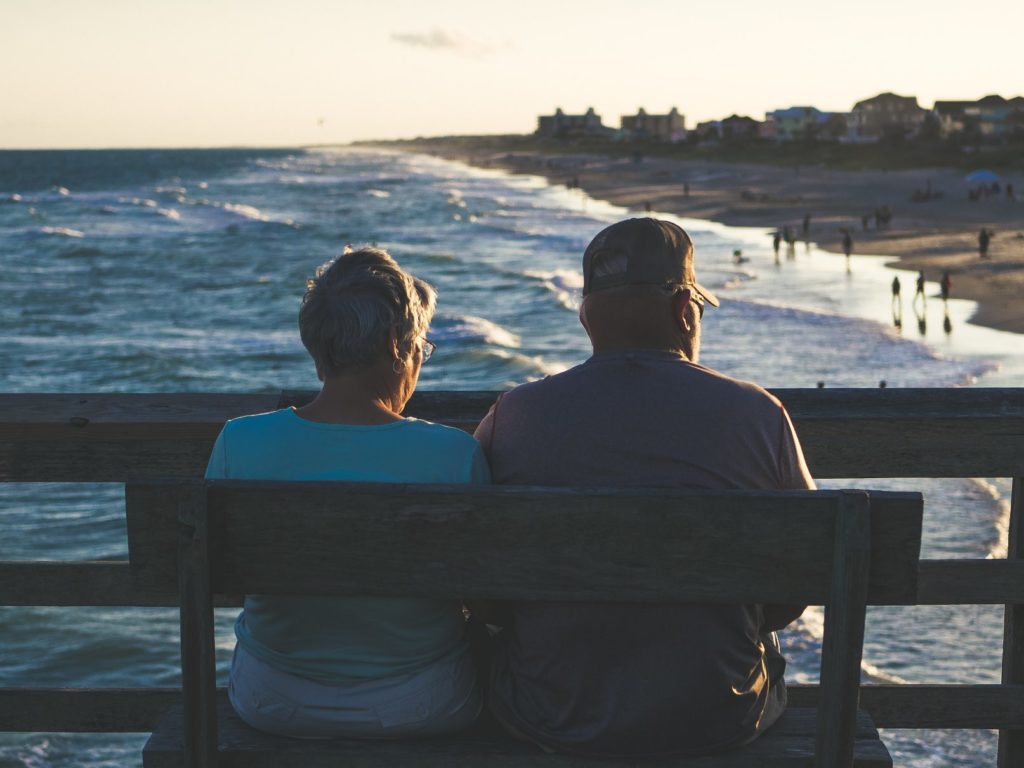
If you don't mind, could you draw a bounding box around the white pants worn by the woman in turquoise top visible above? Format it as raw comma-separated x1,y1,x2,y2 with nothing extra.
227,646,482,738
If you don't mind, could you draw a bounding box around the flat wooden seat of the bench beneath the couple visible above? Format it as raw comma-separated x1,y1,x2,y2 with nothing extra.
142,696,893,768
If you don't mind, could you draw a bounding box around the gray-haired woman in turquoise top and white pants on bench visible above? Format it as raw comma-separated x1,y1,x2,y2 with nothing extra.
206,248,489,738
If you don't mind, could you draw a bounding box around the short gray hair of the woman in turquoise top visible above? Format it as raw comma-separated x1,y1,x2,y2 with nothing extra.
299,247,437,376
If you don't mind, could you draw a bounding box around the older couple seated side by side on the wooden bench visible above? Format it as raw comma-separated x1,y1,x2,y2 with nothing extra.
207,218,814,757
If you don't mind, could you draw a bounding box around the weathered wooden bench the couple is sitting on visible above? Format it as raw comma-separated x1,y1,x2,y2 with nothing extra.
126,481,923,768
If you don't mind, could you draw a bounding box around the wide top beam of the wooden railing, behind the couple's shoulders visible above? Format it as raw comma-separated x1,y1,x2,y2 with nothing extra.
0,388,1024,482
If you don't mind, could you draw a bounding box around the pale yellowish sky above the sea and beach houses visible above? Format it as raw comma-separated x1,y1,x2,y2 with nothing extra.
0,0,1024,148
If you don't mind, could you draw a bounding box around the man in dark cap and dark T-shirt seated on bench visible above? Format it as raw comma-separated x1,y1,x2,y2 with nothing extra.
476,218,814,757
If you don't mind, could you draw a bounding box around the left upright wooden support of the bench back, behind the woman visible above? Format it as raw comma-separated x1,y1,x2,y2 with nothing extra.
177,483,217,768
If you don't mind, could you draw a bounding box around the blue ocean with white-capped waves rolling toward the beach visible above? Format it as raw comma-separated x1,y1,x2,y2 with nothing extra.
0,148,1024,768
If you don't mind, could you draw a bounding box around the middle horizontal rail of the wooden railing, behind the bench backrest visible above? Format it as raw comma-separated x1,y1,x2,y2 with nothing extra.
6,560,1024,607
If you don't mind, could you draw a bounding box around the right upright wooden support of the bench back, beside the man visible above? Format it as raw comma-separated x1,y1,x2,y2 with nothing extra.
814,490,871,768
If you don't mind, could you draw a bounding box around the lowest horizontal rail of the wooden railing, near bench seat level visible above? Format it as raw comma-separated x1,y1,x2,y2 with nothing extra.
0,685,1024,733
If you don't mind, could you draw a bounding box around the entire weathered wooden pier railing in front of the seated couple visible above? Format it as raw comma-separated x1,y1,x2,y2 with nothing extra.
0,389,1024,768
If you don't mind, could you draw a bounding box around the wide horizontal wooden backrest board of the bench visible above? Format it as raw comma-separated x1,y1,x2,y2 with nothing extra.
126,482,922,604
